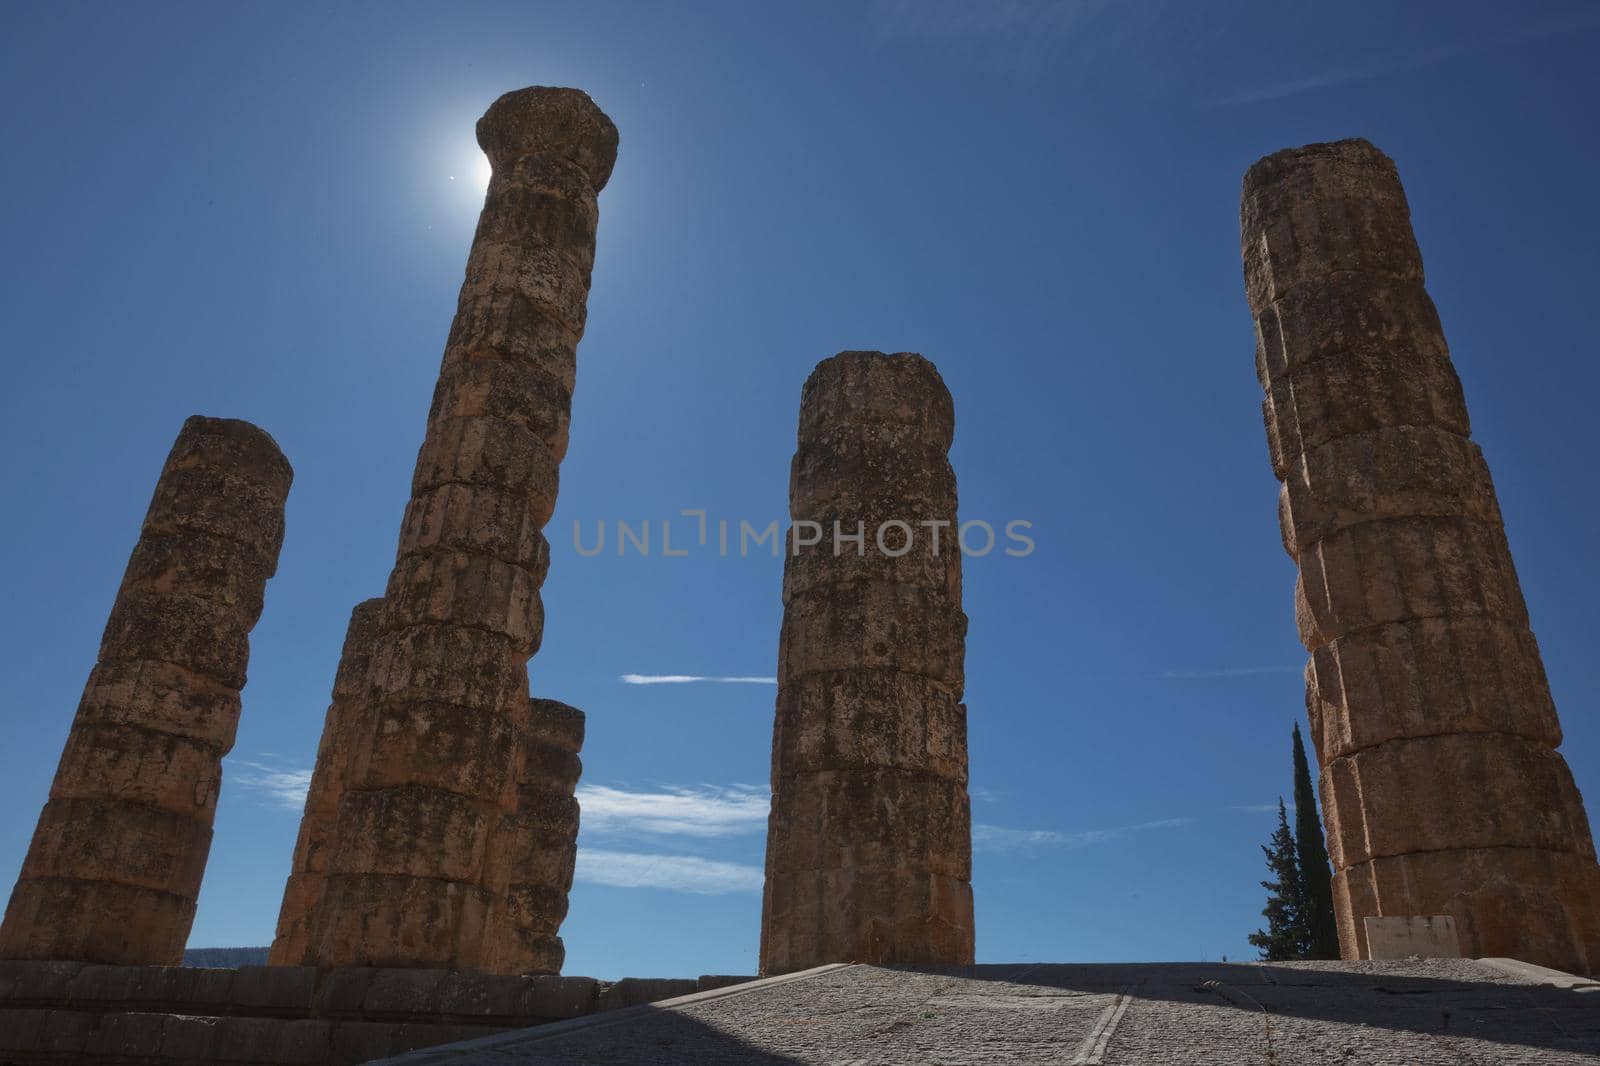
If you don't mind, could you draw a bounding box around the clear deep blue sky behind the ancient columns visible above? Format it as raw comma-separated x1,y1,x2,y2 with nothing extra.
0,0,1600,976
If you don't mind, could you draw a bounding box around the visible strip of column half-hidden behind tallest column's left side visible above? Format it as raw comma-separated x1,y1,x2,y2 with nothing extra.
267,597,384,967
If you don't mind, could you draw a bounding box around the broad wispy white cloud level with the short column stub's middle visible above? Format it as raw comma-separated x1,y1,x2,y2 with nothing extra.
578,784,771,837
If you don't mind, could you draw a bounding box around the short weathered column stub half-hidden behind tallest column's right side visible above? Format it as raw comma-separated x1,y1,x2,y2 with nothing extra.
483,699,584,973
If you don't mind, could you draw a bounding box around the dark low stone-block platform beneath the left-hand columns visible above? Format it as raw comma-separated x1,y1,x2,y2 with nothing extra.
0,962,749,1066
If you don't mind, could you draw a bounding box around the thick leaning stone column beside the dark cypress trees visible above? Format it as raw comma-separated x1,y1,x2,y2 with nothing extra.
1242,141,1600,973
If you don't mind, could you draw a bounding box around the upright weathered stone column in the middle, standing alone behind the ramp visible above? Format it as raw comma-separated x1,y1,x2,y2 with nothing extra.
762,352,973,973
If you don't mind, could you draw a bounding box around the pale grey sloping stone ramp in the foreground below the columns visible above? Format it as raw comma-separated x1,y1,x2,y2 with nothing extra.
386,959,1600,1066
